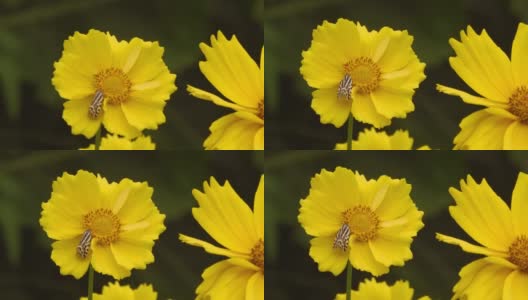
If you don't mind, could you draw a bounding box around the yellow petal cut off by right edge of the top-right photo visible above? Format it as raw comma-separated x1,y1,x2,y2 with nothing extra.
511,23,528,86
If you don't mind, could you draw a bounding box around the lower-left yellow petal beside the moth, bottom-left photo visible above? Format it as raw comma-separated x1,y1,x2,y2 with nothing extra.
51,238,90,279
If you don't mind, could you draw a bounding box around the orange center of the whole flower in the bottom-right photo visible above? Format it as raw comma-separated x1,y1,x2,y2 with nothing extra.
343,205,379,242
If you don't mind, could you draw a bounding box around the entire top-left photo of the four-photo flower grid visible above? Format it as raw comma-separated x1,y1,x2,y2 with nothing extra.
0,0,264,150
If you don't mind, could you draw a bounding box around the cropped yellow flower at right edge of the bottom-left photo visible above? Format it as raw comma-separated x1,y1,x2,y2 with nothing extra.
180,176,264,300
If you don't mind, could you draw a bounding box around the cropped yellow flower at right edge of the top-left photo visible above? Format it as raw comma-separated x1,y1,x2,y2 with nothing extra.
187,31,264,150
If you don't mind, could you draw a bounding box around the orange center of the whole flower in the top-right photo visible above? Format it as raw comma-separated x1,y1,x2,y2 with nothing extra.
344,57,381,94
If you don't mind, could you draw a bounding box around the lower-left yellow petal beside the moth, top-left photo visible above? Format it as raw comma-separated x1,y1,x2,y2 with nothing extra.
62,96,101,138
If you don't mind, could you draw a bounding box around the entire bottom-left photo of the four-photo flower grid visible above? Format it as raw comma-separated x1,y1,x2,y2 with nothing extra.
0,151,264,300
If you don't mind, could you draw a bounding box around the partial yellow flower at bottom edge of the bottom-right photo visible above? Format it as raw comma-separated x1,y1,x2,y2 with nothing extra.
335,279,431,300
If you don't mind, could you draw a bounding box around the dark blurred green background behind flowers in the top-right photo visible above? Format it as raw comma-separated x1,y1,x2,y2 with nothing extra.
265,0,528,150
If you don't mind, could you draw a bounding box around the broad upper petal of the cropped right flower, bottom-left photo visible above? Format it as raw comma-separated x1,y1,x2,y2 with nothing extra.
192,177,257,253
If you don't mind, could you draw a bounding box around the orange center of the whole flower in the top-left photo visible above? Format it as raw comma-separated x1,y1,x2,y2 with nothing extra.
95,68,132,104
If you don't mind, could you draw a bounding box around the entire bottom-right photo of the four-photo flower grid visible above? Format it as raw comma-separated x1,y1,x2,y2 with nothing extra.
265,151,528,300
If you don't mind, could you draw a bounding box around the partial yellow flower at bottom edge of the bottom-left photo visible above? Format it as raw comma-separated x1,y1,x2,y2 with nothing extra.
81,282,158,300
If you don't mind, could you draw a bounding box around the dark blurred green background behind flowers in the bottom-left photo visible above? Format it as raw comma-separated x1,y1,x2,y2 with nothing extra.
0,151,264,300
